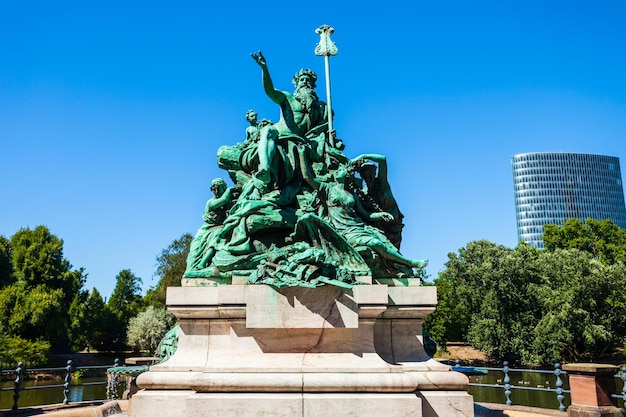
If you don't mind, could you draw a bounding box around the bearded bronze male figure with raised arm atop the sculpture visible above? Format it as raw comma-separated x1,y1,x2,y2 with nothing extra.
252,51,328,184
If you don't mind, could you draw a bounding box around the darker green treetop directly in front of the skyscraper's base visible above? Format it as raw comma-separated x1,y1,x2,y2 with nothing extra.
543,218,626,264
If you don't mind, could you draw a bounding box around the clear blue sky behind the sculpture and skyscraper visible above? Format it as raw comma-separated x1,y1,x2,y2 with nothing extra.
0,0,626,296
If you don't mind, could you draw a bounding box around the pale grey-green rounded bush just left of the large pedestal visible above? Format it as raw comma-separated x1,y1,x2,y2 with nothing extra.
127,306,176,352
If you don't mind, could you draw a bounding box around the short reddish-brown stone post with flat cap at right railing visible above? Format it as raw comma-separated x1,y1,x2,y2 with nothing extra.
563,363,624,417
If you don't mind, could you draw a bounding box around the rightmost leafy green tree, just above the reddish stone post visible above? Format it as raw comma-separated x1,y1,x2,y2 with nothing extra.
528,249,626,363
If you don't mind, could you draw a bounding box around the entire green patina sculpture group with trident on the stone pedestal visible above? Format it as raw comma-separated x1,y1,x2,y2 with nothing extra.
185,26,426,287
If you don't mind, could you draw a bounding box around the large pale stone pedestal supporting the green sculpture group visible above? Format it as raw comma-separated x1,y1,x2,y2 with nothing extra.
130,285,473,417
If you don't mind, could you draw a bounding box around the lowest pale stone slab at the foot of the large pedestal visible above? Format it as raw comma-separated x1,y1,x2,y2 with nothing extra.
129,390,472,417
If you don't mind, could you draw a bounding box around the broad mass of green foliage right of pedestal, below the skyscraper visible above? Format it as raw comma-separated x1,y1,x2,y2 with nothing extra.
426,237,626,365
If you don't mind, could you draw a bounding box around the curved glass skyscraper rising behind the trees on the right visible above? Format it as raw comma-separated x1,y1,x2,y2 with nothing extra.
511,152,626,248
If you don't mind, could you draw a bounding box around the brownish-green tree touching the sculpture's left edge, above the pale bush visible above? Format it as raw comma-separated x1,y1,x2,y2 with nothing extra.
145,233,193,307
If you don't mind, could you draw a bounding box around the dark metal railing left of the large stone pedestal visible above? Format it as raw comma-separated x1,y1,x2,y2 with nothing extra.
0,359,120,410
